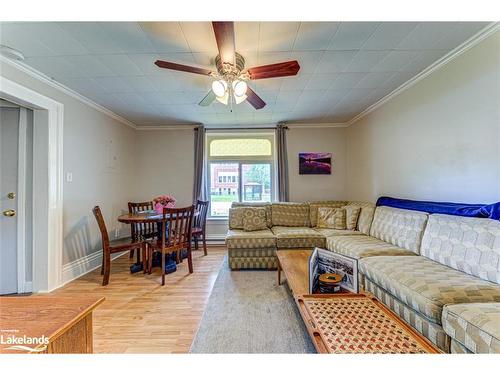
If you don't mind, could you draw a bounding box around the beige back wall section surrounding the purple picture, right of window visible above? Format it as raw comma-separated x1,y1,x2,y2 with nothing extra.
287,126,347,202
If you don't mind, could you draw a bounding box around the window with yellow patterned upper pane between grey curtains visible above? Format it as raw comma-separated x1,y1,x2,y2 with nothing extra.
207,134,274,218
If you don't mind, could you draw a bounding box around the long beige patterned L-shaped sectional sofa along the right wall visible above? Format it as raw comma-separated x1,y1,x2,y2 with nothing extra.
226,201,500,353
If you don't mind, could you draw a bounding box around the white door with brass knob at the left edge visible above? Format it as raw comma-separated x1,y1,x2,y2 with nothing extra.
0,107,20,295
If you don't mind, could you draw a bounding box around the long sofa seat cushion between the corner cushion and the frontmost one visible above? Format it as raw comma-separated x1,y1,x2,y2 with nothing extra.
359,256,500,323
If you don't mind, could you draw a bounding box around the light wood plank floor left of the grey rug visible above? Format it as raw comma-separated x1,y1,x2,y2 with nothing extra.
52,246,226,353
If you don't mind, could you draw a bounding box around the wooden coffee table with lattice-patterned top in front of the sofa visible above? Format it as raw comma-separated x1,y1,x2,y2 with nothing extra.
276,250,440,354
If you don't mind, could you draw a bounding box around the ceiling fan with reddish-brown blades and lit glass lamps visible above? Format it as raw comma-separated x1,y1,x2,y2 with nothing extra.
155,22,300,109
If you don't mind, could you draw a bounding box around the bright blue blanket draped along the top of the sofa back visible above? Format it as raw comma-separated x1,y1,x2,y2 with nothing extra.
377,197,500,220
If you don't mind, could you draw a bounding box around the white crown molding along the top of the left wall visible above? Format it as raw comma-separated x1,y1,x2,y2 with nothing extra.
0,56,137,129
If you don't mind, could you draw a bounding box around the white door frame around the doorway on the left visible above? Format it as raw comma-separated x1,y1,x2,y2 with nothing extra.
0,76,64,292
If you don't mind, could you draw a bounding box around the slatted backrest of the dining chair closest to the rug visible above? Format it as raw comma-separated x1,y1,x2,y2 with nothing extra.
161,206,194,247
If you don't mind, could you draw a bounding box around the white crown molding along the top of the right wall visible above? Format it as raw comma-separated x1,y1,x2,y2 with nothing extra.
346,22,500,126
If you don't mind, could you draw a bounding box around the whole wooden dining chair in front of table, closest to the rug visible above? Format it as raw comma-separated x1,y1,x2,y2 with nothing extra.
146,205,194,285
